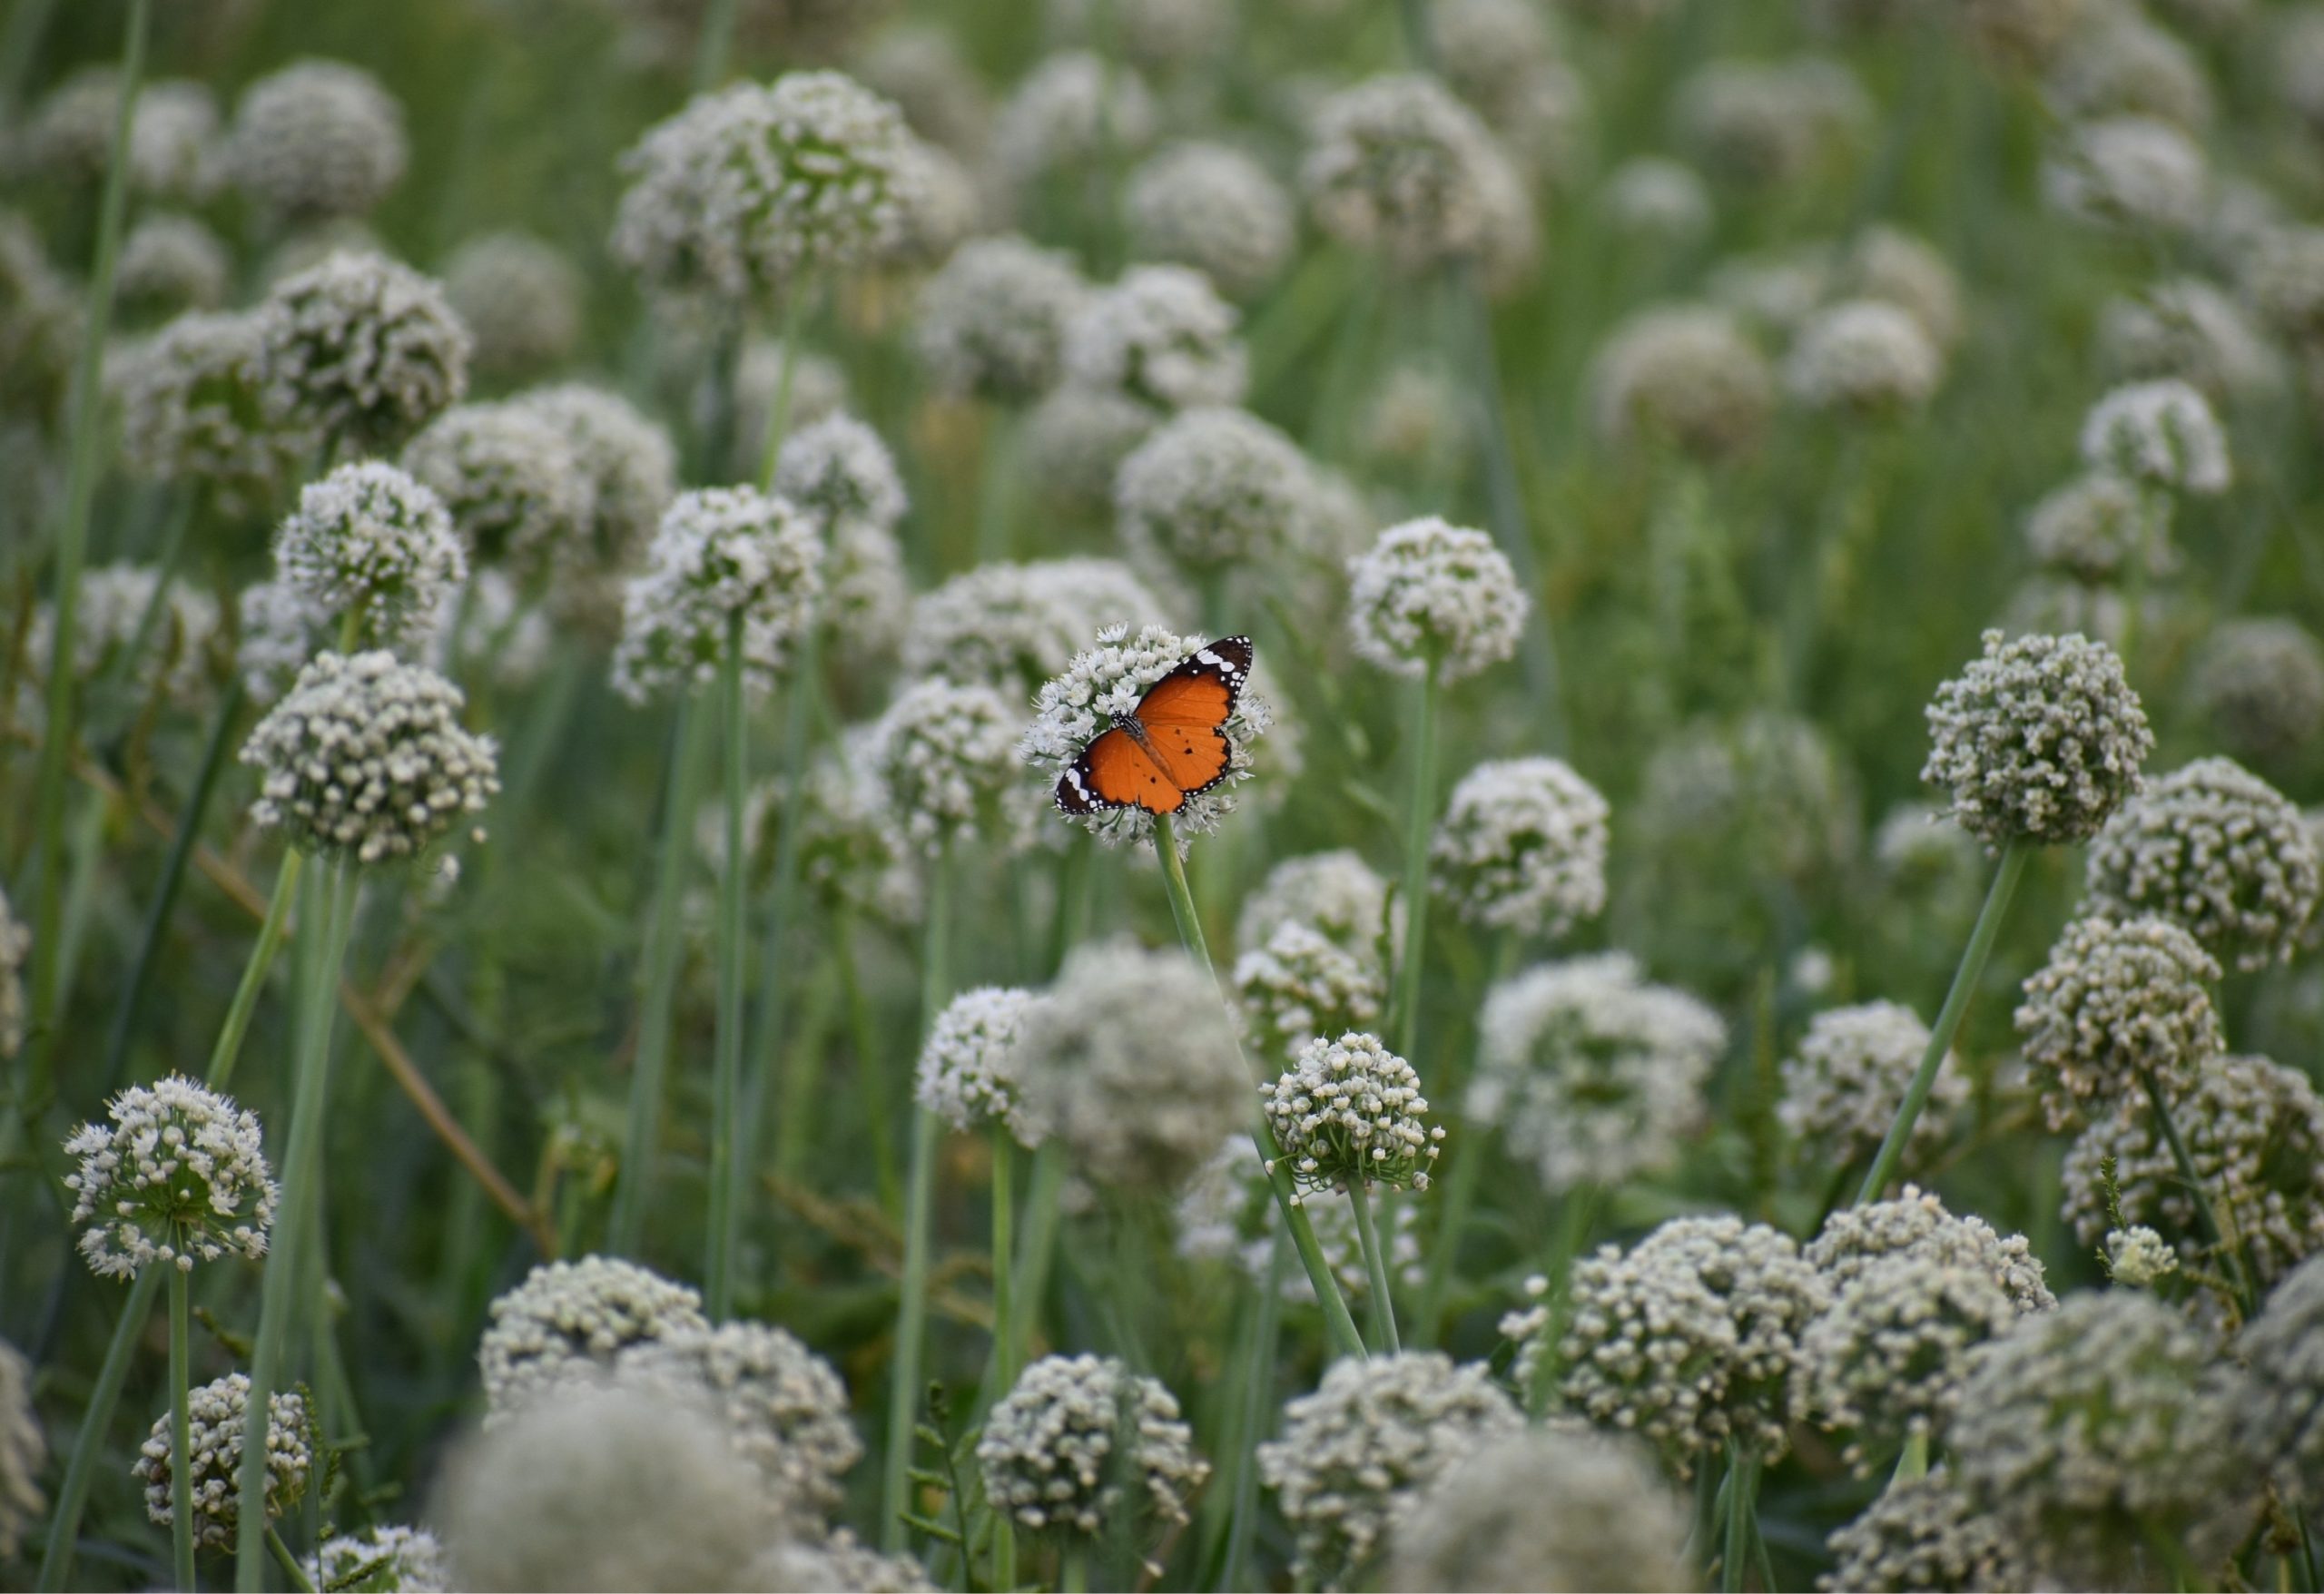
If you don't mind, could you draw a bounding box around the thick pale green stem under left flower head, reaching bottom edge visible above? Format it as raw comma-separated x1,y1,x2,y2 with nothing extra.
235,858,358,1594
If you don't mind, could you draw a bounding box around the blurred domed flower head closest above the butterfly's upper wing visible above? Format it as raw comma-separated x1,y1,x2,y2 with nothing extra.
1113,407,1323,576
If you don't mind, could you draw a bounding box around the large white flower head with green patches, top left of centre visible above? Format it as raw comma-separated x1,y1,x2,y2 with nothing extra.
614,72,911,302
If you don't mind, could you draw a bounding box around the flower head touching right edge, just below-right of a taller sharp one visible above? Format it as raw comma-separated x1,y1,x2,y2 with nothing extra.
2087,757,2324,974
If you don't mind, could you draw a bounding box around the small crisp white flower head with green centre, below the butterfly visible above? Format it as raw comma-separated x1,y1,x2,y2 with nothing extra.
1260,1032,1445,1190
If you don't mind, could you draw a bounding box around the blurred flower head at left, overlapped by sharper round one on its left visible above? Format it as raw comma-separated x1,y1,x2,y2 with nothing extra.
402,404,597,584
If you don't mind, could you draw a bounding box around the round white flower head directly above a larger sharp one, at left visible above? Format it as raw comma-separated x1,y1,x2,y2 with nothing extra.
274,460,468,644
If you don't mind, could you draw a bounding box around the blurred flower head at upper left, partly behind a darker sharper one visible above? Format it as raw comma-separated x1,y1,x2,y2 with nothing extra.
104,311,300,509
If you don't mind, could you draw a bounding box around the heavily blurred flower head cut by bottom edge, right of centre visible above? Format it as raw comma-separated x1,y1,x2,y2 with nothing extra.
1383,1422,1694,1594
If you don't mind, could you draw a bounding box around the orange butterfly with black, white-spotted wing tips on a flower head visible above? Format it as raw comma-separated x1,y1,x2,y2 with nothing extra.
1058,636,1250,813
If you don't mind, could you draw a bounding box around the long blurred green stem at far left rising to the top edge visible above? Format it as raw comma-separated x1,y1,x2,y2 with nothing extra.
18,0,153,1101
